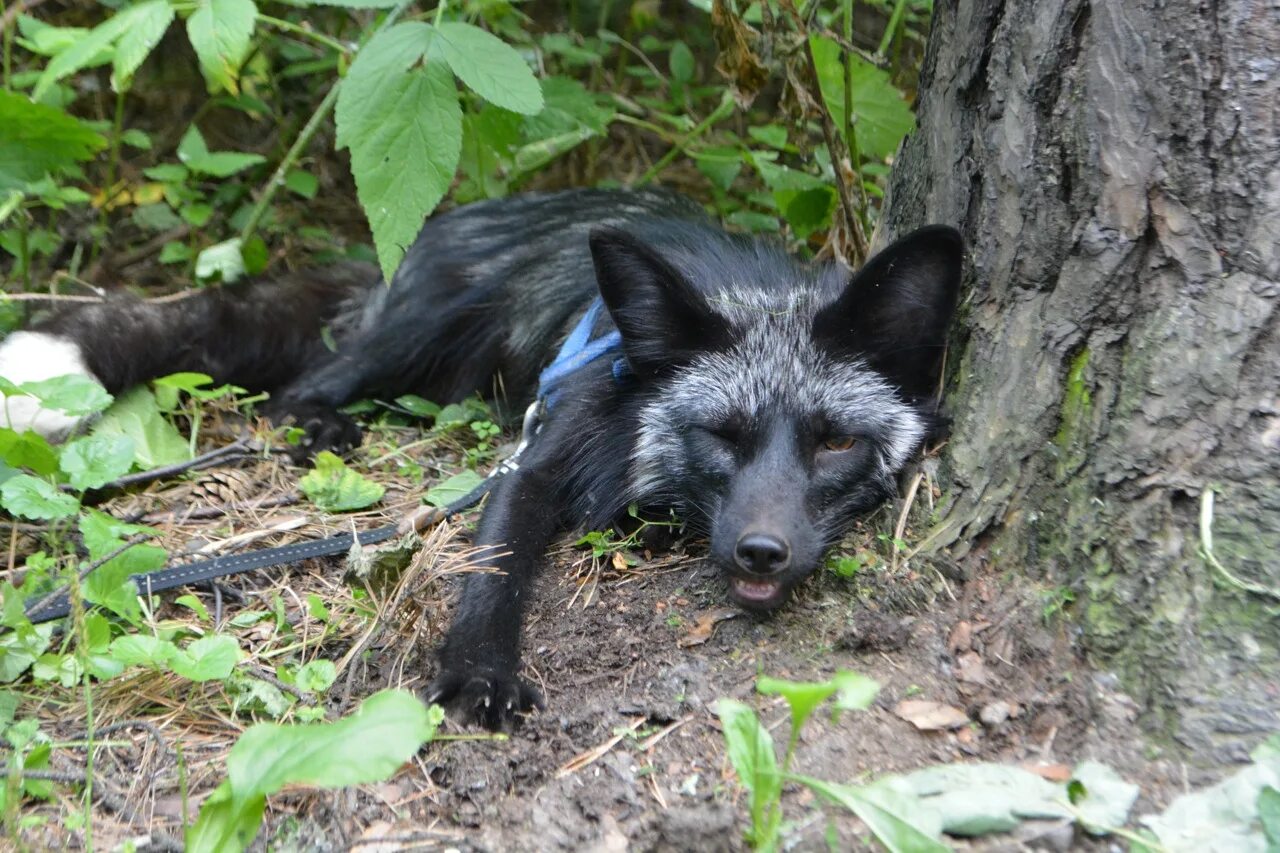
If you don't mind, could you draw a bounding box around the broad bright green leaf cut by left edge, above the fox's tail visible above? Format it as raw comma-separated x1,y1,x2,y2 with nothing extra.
0,90,106,190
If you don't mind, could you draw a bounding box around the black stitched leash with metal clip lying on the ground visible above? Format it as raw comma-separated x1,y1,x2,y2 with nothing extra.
27,402,540,622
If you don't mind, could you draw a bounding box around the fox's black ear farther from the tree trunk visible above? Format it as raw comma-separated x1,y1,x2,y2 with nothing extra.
590,228,728,377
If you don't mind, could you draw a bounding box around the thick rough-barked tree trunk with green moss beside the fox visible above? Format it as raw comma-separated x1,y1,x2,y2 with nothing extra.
882,0,1280,763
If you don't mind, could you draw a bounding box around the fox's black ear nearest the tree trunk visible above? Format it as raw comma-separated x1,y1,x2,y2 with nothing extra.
813,225,964,397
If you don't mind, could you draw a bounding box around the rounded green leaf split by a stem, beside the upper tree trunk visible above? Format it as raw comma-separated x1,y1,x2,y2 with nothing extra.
809,36,915,160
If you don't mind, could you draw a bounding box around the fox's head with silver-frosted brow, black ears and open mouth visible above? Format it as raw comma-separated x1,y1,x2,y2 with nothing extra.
590,225,963,610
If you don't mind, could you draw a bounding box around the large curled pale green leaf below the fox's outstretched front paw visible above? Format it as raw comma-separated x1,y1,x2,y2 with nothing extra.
186,690,443,853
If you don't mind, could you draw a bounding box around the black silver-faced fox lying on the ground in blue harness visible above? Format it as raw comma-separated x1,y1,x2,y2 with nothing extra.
0,190,963,729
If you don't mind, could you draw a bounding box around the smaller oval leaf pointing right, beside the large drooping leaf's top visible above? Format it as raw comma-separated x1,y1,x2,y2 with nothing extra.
428,22,543,115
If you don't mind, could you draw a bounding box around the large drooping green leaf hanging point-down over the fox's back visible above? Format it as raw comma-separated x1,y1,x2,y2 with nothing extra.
335,22,462,280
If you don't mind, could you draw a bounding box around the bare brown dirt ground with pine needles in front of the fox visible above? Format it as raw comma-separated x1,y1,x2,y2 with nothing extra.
12,432,1212,850
